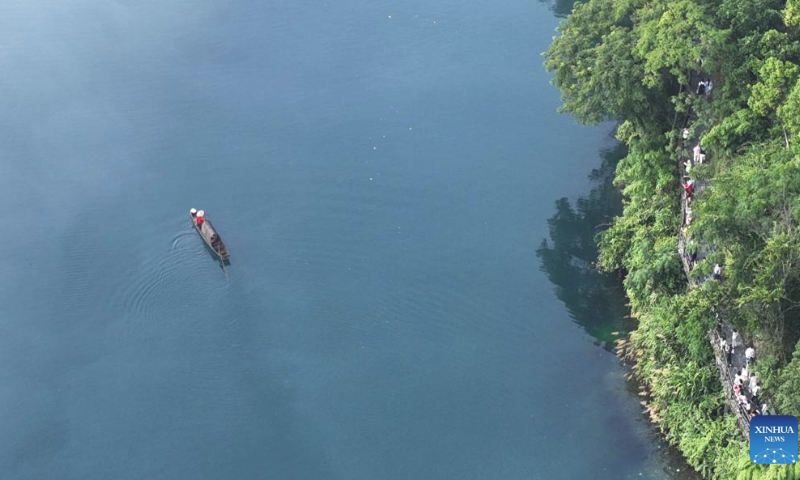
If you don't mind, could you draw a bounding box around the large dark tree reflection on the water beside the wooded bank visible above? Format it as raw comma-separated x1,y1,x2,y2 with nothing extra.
536,144,634,351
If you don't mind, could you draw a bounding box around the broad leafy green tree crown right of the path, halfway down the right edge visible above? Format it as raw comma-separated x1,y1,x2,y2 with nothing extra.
692,143,800,351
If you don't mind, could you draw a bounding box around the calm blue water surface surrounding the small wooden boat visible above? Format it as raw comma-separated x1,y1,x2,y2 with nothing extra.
0,0,689,480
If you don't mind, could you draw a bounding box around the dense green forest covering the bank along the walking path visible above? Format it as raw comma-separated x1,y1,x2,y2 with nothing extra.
545,0,800,479
